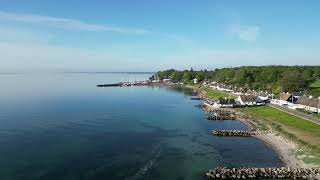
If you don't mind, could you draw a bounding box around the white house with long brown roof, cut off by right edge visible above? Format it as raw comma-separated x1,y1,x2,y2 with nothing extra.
295,96,320,113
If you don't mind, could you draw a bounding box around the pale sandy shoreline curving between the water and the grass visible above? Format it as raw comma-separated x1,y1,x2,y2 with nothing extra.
183,85,319,169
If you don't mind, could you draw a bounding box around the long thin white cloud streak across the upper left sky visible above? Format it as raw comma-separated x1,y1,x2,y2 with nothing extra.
0,11,152,34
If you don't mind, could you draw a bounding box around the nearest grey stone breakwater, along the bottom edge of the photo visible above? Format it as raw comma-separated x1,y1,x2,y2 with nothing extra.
206,167,320,179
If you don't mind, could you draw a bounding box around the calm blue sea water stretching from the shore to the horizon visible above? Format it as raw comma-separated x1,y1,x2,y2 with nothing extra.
0,73,282,180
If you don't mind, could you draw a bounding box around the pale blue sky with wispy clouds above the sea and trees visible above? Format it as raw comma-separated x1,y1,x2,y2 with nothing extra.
0,0,320,72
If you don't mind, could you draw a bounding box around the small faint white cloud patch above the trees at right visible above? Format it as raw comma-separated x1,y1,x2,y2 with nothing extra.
231,24,260,42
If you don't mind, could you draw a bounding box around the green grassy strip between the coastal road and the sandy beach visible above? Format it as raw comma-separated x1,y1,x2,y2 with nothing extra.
239,106,320,165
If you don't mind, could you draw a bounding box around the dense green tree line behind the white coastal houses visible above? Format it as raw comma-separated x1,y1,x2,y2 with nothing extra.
151,66,320,93
